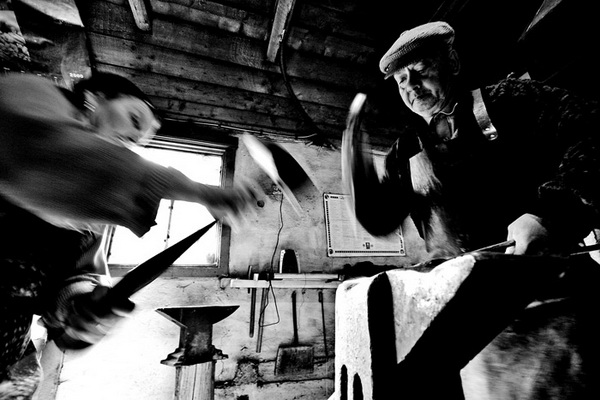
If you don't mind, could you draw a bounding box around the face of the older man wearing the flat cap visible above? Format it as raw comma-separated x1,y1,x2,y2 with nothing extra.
394,57,452,122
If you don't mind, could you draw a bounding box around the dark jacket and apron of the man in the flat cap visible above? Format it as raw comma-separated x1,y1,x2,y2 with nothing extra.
370,79,600,255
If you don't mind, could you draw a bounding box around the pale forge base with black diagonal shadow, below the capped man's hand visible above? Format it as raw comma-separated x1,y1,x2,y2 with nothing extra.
330,253,580,400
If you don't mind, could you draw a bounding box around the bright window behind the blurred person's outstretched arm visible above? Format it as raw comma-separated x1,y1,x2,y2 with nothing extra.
106,133,235,276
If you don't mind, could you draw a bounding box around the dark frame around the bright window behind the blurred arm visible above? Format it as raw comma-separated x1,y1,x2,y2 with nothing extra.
107,126,238,278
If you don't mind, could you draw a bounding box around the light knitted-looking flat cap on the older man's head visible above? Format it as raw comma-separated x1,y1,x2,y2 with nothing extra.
379,21,454,79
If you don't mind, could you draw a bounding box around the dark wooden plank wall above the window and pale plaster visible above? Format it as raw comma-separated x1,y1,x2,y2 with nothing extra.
80,0,396,145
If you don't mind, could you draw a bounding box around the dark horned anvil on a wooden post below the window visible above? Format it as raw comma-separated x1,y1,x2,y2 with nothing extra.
156,305,239,367
